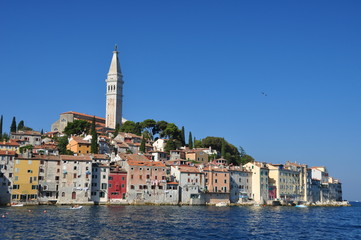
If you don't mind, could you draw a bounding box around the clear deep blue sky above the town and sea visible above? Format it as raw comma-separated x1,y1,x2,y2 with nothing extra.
0,0,361,200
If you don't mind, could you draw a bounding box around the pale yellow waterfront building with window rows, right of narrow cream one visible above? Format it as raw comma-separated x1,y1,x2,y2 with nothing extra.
267,164,303,201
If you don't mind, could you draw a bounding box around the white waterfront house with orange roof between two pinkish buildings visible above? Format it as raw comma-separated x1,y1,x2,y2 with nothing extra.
171,165,205,205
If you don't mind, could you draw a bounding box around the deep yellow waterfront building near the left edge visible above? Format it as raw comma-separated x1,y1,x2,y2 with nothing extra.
11,158,40,203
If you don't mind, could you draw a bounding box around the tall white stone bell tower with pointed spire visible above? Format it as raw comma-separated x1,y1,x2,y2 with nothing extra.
105,45,124,129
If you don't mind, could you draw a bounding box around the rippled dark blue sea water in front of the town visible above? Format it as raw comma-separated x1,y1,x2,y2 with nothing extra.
0,203,361,239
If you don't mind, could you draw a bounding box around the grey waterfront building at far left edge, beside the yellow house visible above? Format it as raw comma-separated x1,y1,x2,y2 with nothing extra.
0,150,16,205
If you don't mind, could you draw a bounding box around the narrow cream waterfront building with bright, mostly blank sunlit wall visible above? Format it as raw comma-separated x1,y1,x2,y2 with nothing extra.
243,161,269,204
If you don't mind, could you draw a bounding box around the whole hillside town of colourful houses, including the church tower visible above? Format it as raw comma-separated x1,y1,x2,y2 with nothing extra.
0,49,342,205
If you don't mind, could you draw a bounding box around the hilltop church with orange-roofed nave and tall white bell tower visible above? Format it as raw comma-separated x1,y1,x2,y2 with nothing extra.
51,46,126,133
